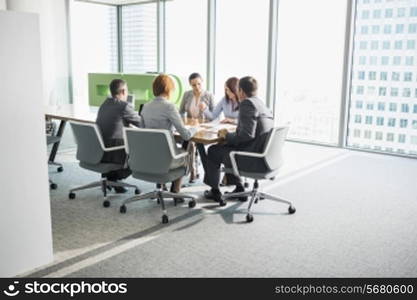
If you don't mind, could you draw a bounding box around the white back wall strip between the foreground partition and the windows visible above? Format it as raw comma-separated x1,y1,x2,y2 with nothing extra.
7,0,69,105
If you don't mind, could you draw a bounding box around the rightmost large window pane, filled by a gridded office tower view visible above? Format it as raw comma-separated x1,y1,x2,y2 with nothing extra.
347,0,417,154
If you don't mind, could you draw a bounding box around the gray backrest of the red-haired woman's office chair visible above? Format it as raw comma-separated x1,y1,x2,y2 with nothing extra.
124,128,175,174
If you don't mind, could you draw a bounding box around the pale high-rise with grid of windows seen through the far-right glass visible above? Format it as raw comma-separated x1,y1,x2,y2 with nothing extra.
347,0,417,155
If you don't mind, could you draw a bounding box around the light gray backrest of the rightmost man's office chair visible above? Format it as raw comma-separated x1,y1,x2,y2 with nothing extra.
264,126,289,171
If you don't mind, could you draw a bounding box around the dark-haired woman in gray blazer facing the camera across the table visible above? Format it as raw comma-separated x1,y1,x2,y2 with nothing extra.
180,73,214,183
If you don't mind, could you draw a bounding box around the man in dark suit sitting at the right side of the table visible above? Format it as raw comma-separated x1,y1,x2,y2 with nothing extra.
204,76,274,205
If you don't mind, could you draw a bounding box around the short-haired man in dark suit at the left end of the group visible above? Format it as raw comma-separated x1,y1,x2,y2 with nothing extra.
96,79,140,193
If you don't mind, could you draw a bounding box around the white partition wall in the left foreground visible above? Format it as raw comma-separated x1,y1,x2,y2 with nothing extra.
0,10,53,277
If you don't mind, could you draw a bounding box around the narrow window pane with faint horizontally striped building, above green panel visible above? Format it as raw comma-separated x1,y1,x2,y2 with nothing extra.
122,3,158,73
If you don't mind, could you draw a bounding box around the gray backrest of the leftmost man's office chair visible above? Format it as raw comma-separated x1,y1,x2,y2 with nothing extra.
70,122,104,164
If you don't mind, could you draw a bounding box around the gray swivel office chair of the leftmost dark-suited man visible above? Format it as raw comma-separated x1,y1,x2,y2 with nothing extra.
68,122,140,207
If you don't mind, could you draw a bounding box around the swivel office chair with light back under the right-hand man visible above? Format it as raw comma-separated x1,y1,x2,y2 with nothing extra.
222,126,295,223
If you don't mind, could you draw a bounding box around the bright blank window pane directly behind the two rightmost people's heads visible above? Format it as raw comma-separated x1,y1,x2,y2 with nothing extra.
215,0,269,100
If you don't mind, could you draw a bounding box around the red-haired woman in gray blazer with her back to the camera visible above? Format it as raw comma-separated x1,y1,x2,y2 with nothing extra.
140,74,197,193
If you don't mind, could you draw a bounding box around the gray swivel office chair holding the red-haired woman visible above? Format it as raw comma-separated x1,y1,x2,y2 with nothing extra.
120,128,197,224
